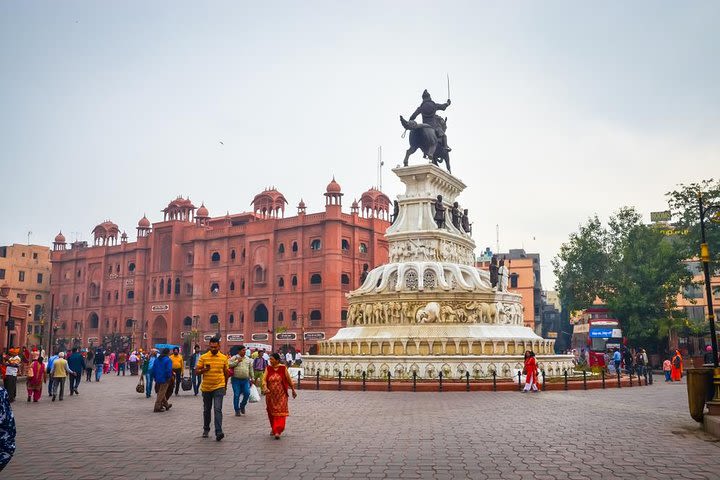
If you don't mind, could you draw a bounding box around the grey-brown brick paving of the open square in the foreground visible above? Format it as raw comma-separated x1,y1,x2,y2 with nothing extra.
0,376,720,480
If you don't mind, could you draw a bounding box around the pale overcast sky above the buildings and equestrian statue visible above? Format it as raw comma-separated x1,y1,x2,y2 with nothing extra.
0,1,720,289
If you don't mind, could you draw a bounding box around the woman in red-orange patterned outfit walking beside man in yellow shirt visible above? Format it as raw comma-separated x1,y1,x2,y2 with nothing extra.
262,352,297,440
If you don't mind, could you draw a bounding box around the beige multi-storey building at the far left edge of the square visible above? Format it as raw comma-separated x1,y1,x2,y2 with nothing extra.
0,243,50,348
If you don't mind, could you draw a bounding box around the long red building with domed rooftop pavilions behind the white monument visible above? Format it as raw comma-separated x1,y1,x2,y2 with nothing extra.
51,179,390,352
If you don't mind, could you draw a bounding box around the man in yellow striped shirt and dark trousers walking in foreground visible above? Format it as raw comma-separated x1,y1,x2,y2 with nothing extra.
195,337,228,442
